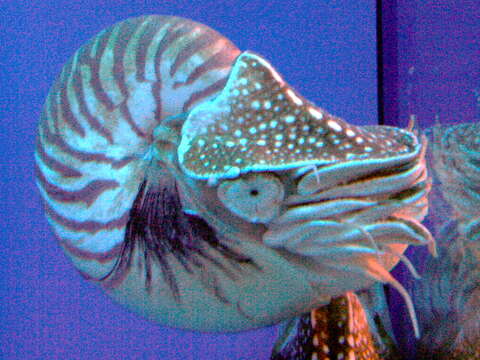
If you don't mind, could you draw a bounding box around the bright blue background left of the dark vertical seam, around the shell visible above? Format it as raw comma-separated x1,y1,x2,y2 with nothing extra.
0,0,377,360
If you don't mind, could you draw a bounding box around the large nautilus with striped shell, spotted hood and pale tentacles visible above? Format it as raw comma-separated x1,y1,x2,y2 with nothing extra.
36,16,433,331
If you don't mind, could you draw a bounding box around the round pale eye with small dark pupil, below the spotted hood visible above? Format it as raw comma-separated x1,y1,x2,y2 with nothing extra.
217,173,285,223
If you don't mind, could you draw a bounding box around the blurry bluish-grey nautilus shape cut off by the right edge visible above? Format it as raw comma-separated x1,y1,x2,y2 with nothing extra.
412,122,480,360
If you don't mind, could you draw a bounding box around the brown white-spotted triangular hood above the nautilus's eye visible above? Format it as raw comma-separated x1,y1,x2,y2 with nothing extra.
178,51,420,183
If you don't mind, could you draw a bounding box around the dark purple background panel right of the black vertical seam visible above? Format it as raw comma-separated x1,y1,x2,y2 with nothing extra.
384,0,480,129
